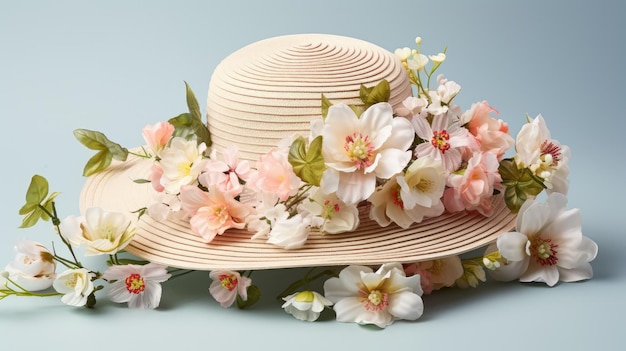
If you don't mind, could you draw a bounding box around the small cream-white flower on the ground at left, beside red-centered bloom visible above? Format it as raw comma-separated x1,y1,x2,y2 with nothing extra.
52,268,95,307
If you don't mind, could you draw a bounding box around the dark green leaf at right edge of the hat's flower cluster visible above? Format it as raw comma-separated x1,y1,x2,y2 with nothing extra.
498,159,546,213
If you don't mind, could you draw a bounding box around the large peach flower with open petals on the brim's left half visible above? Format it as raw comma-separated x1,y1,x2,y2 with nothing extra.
180,185,251,242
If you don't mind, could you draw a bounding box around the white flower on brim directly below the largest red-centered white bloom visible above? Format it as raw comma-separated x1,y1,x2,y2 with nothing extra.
300,189,359,234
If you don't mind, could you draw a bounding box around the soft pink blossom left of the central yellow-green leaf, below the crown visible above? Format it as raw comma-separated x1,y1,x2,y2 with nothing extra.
250,149,300,201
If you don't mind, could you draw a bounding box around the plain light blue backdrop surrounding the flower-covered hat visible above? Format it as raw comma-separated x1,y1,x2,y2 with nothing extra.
0,0,626,350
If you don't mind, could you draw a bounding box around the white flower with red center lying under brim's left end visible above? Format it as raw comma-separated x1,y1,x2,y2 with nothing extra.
102,263,171,308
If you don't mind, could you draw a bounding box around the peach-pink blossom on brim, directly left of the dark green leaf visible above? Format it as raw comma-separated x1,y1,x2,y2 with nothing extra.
443,152,502,216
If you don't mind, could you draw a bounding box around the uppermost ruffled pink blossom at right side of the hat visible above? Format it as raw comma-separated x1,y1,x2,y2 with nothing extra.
461,101,514,159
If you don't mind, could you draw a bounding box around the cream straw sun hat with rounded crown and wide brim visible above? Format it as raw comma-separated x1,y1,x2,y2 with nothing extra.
81,34,516,270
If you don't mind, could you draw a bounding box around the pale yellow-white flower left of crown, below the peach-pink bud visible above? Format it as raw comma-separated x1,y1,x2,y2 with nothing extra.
159,137,206,194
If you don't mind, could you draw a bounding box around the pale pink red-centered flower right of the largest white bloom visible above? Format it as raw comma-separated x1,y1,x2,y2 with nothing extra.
411,113,469,173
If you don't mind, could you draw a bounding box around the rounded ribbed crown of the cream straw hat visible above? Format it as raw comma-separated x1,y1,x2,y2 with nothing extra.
207,34,411,160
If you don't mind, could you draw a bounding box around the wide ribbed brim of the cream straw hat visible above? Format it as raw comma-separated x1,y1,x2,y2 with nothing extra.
80,151,517,270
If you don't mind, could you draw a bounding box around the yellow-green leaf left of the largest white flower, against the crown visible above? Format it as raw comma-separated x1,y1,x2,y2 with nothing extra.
288,135,325,186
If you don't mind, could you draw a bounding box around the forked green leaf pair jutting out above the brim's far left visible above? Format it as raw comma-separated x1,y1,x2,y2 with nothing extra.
74,129,128,177
